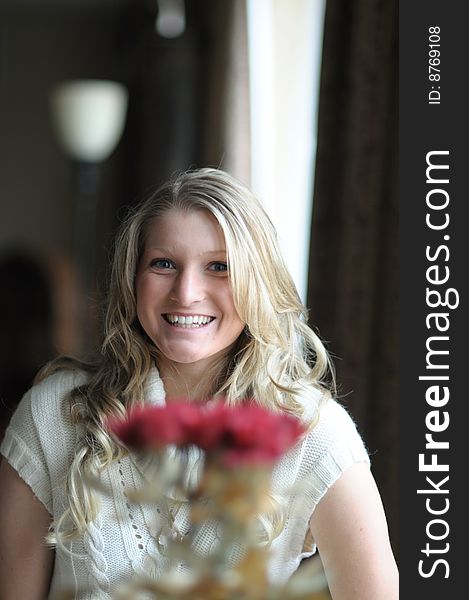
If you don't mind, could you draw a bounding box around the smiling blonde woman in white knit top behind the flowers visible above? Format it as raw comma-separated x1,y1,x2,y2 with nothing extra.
0,169,398,600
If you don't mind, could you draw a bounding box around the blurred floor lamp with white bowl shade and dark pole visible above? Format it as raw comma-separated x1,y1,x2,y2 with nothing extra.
50,79,128,346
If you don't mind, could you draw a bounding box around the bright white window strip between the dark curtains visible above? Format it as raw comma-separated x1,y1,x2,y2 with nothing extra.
246,0,325,301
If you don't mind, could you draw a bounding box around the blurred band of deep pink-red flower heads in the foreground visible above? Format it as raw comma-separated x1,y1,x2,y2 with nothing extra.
110,402,304,467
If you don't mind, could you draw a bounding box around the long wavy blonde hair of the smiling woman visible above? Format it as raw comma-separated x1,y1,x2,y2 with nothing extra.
40,168,335,541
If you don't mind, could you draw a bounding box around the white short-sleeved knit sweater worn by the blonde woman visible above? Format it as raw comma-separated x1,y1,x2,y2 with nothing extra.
1,369,369,600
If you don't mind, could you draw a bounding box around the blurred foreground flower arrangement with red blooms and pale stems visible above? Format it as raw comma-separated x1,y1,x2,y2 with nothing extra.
109,402,330,600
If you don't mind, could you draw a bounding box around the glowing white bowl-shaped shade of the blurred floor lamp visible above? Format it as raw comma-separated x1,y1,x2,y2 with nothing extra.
50,79,128,162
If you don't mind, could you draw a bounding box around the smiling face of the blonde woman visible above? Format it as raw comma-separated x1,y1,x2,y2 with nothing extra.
136,209,244,367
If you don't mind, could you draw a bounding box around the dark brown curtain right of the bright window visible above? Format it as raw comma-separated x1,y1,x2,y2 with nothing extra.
308,0,398,557
